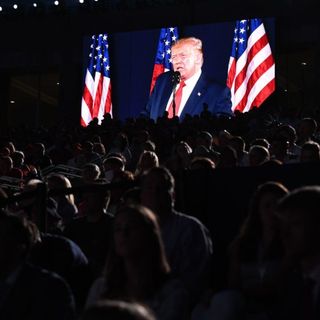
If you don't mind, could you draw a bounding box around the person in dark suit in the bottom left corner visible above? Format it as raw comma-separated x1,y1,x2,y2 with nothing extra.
0,214,75,320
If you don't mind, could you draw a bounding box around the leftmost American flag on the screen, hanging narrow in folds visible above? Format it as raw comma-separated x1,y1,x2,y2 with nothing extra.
81,34,112,127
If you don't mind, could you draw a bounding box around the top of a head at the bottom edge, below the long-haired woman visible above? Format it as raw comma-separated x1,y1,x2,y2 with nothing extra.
81,300,156,320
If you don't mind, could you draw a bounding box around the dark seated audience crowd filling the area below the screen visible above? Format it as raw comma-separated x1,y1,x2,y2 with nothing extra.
0,104,320,320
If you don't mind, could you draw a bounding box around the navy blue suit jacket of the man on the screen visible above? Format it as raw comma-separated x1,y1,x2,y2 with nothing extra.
144,71,232,120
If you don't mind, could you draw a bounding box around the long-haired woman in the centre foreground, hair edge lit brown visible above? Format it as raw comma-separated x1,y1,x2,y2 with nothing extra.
87,205,189,320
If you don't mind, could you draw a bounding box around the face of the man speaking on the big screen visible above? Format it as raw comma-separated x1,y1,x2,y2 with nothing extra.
171,43,202,80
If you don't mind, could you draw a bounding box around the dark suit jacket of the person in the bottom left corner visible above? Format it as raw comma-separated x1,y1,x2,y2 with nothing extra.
0,264,75,320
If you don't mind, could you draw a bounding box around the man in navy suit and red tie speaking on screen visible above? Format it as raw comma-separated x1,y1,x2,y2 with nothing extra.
146,37,232,120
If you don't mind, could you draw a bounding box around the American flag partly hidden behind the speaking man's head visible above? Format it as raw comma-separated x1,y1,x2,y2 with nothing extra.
150,27,178,92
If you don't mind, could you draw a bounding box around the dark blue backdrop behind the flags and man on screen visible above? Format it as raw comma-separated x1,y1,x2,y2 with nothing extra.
79,18,275,120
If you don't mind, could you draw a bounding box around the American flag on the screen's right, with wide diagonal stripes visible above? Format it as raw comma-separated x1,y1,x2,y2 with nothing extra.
227,19,275,112
